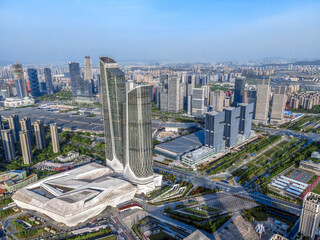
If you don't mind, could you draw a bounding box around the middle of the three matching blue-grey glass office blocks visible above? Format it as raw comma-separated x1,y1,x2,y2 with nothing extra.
223,107,240,147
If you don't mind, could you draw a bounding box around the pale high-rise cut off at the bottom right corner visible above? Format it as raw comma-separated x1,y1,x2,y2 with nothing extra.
299,192,320,239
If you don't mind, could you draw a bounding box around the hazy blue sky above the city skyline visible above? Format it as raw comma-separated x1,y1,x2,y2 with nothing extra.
0,0,320,63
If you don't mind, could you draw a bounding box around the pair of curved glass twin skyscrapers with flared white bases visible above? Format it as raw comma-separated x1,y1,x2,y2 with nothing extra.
100,57,161,192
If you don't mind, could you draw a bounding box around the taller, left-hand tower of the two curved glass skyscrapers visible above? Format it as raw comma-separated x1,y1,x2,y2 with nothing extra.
100,57,126,171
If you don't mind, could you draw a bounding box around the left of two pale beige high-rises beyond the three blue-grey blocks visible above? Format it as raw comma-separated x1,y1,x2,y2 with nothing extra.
255,79,270,123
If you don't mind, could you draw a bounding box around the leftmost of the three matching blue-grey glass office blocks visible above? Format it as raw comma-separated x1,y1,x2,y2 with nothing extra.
205,112,225,153
